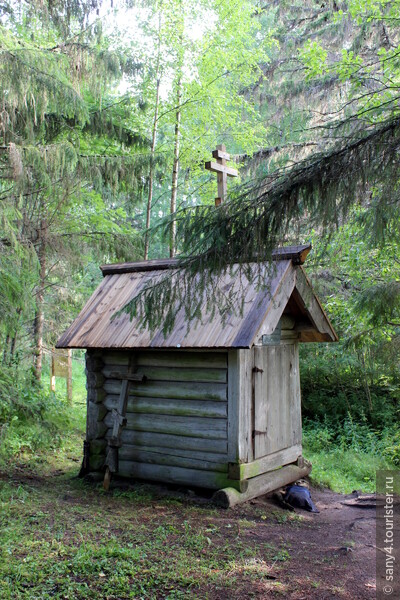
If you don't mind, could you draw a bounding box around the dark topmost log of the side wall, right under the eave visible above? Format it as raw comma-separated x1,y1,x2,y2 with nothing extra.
102,350,227,369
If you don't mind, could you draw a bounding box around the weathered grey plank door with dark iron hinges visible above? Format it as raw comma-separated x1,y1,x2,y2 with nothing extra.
253,344,301,459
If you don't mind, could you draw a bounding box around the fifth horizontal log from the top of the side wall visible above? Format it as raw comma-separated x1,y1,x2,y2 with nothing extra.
104,412,227,439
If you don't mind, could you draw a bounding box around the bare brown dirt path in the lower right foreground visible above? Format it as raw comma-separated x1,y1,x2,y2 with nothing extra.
234,489,376,600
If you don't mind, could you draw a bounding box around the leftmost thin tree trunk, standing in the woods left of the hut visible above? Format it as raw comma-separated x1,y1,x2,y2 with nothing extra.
34,219,47,381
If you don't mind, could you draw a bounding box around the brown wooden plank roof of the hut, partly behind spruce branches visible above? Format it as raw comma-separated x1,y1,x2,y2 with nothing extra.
57,246,337,349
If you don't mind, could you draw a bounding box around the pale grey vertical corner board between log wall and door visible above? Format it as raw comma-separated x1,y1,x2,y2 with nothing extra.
228,350,253,463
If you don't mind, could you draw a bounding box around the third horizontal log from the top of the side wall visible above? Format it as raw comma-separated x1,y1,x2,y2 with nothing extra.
104,379,227,401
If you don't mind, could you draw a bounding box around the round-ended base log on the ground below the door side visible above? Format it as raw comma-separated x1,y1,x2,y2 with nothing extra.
213,461,311,508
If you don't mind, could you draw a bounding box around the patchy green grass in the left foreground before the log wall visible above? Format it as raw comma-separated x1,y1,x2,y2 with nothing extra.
0,465,290,600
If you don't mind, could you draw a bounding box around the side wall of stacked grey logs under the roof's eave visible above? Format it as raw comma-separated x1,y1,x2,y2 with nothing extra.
88,350,242,489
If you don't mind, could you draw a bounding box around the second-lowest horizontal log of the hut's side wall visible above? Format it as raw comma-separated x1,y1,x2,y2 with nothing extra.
119,446,228,473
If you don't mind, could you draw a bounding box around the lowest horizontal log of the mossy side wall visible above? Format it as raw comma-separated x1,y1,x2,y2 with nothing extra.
119,460,247,490
